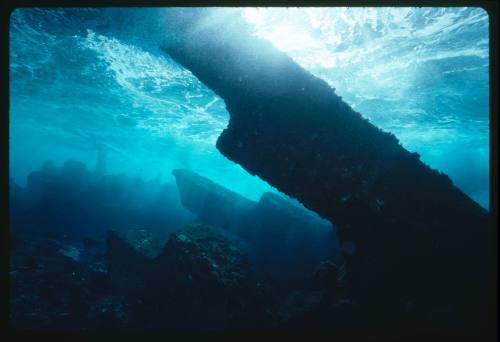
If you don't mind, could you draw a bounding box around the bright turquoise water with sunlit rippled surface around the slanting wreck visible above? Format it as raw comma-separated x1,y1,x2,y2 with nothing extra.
10,8,489,208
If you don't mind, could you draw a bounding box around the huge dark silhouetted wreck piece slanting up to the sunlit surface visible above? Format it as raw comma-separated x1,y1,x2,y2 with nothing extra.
163,9,495,327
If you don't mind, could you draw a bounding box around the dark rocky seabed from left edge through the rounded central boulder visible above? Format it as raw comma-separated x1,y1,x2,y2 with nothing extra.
9,225,272,331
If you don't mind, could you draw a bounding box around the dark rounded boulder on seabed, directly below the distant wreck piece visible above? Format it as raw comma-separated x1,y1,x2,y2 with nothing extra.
149,225,274,330
